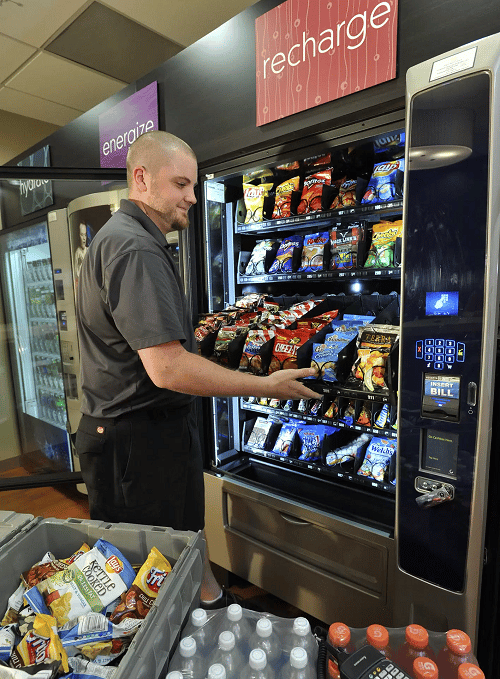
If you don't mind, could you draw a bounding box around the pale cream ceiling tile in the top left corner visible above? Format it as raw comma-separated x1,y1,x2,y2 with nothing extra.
0,0,88,47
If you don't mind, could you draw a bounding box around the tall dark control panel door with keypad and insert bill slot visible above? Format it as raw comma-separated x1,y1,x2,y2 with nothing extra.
394,30,500,660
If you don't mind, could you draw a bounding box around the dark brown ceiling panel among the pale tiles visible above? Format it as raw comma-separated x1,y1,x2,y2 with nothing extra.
45,2,182,83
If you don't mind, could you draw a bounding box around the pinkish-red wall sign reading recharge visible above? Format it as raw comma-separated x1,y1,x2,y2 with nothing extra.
255,0,398,126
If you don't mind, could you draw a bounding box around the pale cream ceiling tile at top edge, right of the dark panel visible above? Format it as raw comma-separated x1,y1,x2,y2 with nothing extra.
100,0,256,47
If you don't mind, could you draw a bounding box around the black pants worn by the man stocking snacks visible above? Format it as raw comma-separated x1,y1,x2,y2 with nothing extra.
76,408,205,531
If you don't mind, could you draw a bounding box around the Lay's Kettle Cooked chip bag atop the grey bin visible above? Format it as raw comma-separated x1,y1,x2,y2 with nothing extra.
25,539,135,627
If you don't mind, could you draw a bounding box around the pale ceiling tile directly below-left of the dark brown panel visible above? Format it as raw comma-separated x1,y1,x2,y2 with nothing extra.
5,53,125,111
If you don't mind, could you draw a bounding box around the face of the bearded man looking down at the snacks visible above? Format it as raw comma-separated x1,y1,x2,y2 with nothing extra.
144,152,198,233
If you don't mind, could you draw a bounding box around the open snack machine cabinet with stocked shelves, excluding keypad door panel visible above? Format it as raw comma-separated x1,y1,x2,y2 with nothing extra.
196,111,405,625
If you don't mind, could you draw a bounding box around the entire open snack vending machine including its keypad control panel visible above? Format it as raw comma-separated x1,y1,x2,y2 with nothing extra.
196,30,500,676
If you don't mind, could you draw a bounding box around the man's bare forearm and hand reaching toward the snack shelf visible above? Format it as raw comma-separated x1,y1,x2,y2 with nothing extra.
138,341,319,400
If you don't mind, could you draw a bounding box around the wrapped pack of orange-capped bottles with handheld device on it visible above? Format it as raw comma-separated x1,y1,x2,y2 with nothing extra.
318,622,484,679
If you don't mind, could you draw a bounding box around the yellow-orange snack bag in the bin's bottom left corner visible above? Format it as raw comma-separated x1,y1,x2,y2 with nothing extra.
10,616,69,672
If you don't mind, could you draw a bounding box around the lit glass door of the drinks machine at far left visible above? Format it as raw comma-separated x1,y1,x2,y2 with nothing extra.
0,221,73,473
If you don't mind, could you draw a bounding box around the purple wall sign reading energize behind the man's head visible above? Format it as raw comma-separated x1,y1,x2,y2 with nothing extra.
99,81,158,168
